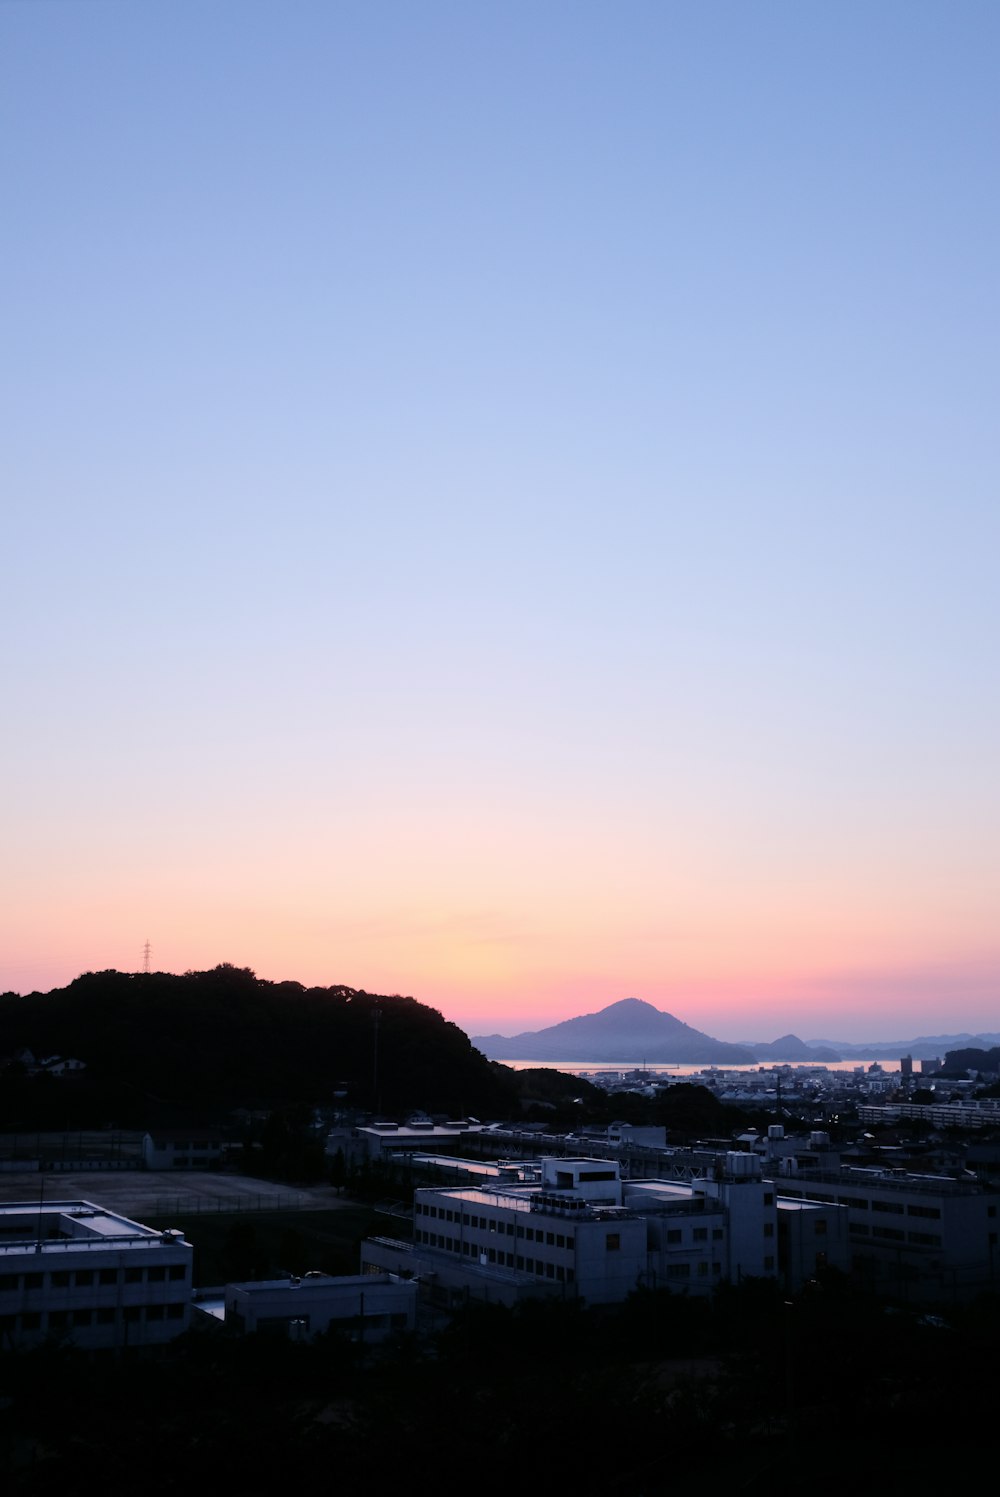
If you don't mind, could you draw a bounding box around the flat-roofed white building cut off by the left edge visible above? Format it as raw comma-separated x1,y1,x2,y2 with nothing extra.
0,1201,193,1349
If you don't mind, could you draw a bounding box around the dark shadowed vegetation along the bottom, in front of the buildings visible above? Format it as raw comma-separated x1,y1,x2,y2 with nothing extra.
0,1280,1000,1497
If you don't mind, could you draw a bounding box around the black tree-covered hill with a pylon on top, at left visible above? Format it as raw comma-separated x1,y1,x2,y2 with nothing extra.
0,964,510,1124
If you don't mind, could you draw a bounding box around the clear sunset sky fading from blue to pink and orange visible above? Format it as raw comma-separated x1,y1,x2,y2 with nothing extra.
0,0,1000,1040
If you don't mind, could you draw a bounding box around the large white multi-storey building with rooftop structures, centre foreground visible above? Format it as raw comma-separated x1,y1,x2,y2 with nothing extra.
362,1154,808,1304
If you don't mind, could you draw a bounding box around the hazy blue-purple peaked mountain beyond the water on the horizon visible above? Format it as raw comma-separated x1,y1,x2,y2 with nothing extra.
472,998,754,1066
